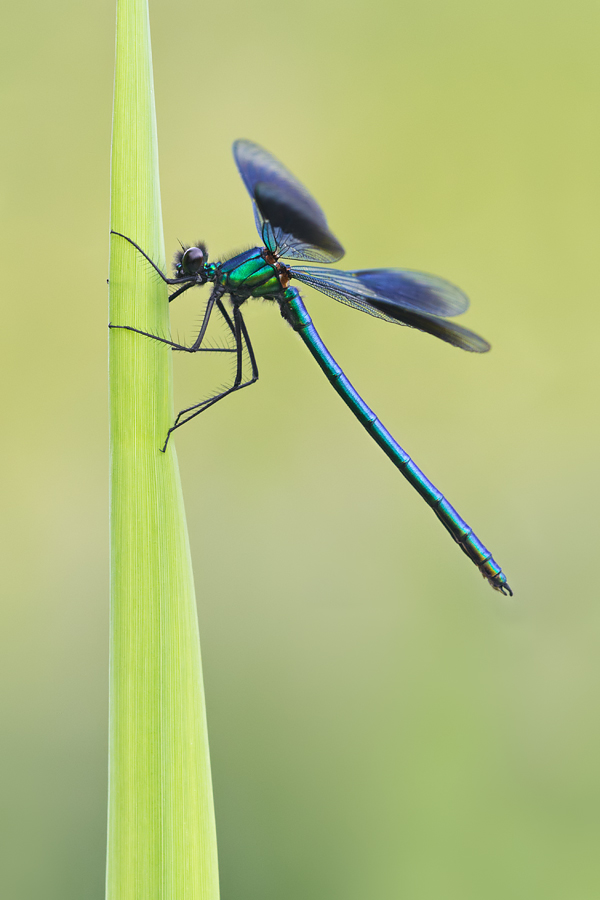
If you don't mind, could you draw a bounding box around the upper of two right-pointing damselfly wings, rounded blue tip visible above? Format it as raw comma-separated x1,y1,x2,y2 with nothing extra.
352,269,469,316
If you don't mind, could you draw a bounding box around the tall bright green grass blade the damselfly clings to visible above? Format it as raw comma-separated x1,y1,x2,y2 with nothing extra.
107,0,219,900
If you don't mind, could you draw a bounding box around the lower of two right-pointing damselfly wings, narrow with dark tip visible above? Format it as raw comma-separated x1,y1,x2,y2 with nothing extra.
290,266,490,353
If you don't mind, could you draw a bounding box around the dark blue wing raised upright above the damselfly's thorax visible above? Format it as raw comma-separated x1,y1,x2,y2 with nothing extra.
233,140,344,263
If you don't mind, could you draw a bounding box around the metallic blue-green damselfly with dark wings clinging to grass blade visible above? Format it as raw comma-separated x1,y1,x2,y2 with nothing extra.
111,140,512,596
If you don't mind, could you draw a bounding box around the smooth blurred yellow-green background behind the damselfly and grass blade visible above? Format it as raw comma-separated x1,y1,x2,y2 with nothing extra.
0,0,600,900
